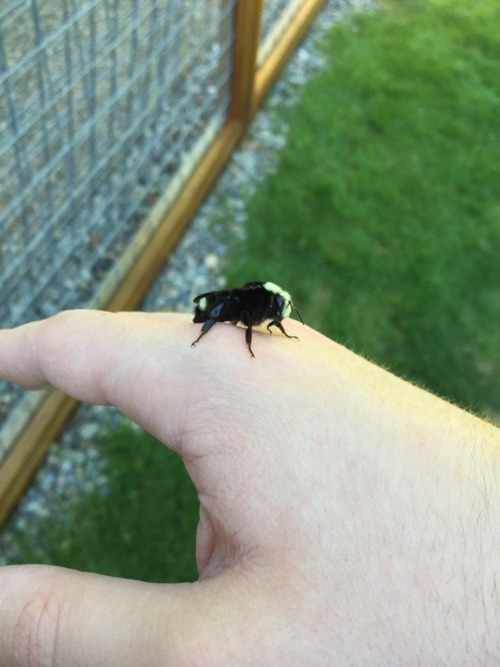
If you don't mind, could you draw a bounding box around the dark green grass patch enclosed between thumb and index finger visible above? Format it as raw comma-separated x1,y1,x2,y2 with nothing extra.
7,426,198,582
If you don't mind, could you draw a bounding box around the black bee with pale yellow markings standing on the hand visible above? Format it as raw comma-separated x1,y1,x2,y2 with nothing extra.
191,281,304,358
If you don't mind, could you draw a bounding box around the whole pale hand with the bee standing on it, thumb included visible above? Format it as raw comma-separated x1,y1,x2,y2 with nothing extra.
0,311,500,667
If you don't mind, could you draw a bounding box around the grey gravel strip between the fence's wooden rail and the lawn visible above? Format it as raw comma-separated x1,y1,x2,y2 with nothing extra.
0,0,373,565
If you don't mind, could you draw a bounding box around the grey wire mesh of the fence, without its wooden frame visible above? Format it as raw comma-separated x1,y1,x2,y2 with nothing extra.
0,0,318,463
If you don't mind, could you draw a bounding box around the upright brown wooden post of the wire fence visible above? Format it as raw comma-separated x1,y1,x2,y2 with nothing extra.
229,0,264,127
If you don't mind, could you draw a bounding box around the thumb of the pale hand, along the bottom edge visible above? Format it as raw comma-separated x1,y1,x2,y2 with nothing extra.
0,565,282,667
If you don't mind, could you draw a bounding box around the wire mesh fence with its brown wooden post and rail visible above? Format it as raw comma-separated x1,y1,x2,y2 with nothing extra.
0,0,324,523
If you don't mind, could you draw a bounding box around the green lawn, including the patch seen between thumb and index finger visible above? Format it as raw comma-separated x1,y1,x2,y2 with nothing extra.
4,0,500,581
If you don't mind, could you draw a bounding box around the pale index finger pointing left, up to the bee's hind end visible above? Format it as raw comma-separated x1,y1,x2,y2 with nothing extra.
0,311,191,448
